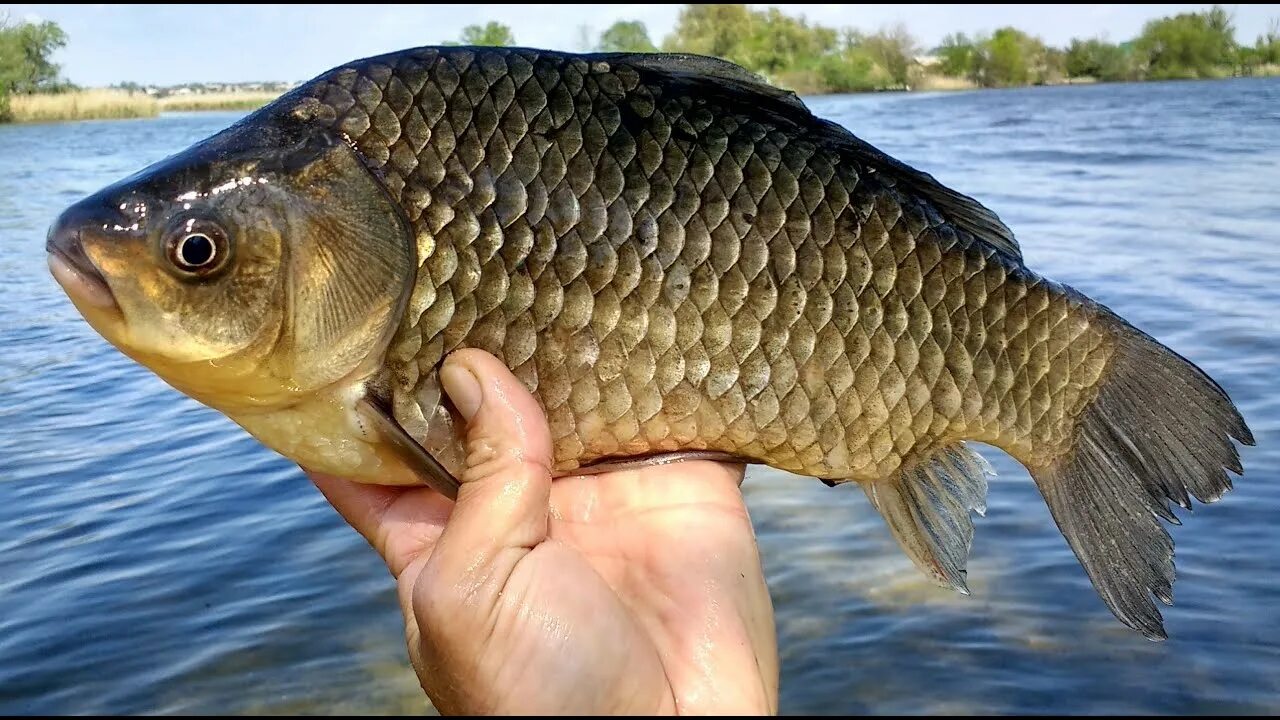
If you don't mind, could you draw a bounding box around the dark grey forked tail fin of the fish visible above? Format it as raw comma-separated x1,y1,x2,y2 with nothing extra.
1032,310,1253,639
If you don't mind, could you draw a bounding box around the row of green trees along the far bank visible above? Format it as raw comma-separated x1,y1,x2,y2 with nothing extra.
0,5,1280,122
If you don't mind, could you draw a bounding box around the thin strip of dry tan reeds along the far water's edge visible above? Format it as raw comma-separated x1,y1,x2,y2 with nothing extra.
0,68,1280,127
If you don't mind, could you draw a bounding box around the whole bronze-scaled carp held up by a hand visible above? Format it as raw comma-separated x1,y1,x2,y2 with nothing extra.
46,46,1253,639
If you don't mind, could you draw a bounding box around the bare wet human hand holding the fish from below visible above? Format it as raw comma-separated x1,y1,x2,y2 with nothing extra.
312,350,778,715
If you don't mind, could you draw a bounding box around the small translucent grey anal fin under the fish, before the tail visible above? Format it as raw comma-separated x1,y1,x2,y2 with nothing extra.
863,442,992,594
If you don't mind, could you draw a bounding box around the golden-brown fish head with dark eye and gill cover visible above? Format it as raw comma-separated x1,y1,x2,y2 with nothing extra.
46,105,416,416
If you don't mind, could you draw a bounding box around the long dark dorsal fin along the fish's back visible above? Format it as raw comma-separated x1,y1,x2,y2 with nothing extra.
590,53,1023,261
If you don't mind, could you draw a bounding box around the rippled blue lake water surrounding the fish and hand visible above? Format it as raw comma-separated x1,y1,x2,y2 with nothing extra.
0,79,1280,714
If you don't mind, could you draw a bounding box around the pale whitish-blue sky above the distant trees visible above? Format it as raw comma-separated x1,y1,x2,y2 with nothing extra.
0,4,1280,86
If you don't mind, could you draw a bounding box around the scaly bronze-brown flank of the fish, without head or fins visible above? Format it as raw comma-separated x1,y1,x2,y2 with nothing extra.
296,50,1108,479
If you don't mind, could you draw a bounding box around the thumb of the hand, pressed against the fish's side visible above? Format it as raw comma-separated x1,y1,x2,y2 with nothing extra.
430,350,552,594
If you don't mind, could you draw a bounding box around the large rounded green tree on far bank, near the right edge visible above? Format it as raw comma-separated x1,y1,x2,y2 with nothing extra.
1134,5,1235,79
